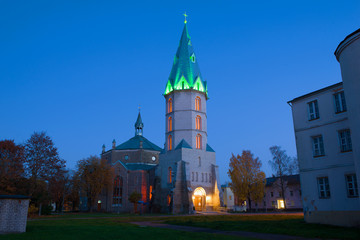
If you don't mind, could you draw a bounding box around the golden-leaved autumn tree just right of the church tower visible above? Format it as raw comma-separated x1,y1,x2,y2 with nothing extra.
228,150,266,212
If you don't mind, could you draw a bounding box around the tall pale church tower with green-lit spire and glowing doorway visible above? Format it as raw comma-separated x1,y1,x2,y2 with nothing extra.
158,20,221,213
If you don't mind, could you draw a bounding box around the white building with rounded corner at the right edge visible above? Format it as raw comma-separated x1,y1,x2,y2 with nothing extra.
289,29,360,226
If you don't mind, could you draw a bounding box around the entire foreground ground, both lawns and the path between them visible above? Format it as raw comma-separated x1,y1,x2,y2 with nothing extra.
0,214,360,240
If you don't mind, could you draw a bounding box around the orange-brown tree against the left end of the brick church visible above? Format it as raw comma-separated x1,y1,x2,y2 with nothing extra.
77,156,113,211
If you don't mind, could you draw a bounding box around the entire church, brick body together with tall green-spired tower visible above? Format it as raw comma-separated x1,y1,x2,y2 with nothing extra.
98,19,222,213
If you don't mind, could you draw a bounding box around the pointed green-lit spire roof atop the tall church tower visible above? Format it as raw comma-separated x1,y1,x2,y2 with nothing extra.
165,23,207,95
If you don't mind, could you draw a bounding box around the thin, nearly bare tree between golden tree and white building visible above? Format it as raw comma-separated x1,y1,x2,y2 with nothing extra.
269,146,298,209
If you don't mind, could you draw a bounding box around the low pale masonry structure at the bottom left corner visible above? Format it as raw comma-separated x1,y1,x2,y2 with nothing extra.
0,195,30,233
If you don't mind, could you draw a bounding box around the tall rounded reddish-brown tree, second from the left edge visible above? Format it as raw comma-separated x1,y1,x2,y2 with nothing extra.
25,132,65,208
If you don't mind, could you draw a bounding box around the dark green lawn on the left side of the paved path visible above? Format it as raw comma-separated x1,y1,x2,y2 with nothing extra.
0,215,253,240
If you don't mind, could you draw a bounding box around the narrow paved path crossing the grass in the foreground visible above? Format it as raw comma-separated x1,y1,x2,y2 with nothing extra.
130,222,319,240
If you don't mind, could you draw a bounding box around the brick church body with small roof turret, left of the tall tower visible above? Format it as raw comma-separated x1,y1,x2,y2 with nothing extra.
97,113,161,212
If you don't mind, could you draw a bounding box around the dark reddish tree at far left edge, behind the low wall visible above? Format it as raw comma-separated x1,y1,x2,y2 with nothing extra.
0,140,26,194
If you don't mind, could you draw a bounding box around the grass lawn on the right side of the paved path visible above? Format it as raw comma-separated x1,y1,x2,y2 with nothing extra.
165,214,360,240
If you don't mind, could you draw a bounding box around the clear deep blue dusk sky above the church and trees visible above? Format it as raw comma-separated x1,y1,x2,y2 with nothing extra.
0,0,360,183
